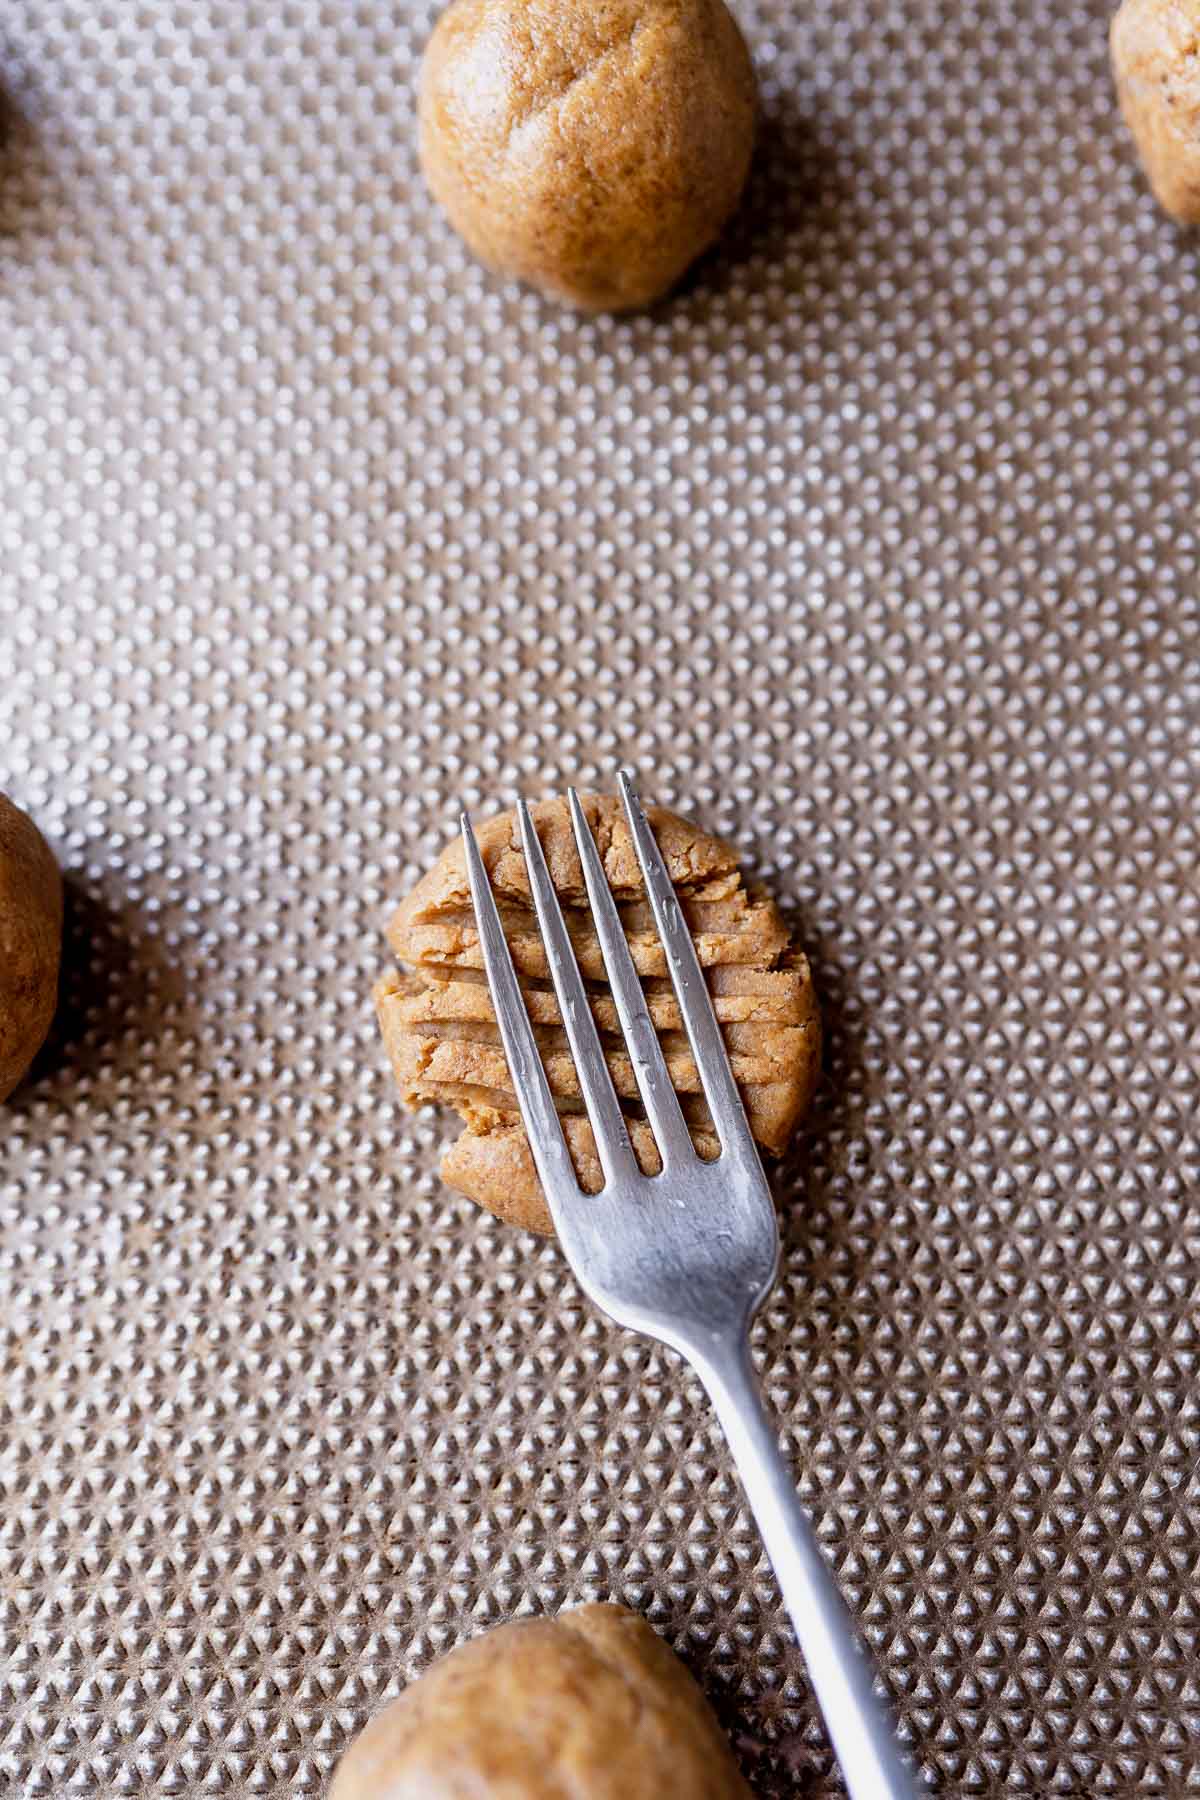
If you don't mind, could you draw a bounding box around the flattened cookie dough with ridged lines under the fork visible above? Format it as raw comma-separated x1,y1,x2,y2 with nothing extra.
374,794,820,1233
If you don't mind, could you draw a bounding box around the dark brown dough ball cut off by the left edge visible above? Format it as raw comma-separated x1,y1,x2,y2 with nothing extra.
0,794,63,1100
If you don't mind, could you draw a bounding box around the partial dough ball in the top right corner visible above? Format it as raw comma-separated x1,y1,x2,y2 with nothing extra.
1112,0,1200,225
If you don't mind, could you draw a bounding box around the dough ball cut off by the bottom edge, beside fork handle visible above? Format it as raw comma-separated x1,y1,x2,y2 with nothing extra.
329,1606,750,1800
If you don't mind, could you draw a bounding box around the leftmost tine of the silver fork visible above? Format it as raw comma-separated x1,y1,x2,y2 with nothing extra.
461,814,579,1202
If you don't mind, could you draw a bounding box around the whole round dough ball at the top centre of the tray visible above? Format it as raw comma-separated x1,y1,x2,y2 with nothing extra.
419,0,756,311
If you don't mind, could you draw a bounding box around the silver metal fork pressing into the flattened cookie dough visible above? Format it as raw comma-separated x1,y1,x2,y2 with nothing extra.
462,774,925,1800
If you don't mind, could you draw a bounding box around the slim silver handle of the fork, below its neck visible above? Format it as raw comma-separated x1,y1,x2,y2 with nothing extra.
696,1339,928,1800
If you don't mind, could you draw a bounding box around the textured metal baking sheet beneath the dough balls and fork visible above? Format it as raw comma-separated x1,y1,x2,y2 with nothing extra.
0,0,1200,1800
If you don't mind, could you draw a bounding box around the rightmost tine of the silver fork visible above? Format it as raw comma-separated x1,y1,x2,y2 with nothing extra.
619,769,754,1150
